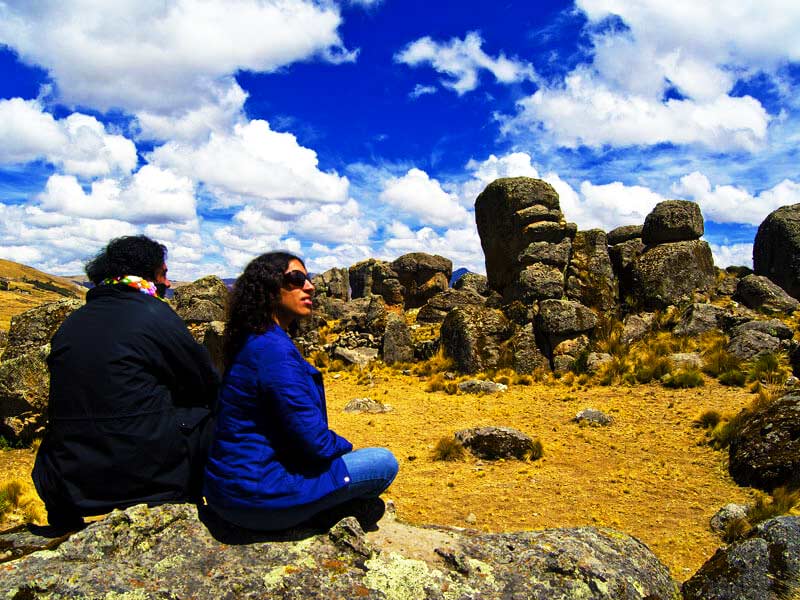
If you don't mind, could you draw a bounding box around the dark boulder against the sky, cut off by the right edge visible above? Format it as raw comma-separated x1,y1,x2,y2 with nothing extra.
753,204,800,298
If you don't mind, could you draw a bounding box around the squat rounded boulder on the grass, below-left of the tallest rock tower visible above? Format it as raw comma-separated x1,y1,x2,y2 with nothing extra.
440,306,513,373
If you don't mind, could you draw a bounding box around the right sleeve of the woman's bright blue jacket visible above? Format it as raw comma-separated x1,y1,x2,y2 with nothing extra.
259,355,353,462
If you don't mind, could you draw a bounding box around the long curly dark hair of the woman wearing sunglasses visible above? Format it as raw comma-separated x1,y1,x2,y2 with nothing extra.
222,252,305,371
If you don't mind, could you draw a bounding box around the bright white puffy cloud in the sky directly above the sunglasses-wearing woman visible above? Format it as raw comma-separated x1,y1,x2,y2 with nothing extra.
148,120,349,214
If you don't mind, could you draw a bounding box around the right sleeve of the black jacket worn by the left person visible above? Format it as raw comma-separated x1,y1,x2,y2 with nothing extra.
149,307,220,411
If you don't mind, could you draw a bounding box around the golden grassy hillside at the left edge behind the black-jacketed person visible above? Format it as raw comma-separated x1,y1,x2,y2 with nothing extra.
0,258,86,331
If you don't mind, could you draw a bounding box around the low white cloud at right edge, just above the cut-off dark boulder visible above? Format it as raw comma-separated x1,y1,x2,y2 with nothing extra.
672,171,800,225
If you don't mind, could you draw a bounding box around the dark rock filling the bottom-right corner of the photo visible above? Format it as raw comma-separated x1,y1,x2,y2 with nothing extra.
681,517,800,600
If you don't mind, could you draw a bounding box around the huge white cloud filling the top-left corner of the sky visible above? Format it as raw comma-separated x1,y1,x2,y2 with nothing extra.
0,0,354,116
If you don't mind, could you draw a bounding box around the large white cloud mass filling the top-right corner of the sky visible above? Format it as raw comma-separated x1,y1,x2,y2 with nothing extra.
503,0,800,152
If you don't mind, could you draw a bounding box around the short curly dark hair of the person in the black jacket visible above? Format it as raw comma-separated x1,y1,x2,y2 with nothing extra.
86,235,167,285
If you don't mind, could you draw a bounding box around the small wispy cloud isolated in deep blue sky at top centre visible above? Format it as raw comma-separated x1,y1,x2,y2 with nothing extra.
395,31,535,96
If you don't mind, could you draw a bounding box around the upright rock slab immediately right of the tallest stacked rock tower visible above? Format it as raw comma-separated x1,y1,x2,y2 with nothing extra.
566,229,617,311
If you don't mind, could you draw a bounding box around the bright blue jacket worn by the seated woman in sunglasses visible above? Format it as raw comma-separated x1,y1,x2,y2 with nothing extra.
205,325,353,509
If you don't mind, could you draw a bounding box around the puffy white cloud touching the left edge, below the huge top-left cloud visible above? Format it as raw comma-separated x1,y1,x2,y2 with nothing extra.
0,98,137,177
